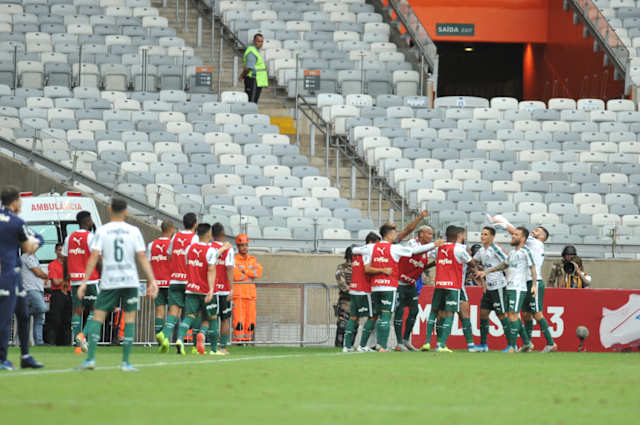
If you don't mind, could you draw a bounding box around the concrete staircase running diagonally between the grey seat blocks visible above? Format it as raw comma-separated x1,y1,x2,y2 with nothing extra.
153,0,400,226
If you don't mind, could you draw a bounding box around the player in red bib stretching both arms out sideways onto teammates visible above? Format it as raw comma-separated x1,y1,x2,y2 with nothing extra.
353,223,442,352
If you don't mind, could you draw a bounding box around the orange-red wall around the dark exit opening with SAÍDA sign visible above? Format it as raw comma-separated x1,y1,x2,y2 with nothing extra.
409,0,624,100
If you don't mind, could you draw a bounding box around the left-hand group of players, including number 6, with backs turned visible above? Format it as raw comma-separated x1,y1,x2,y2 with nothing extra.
63,199,239,371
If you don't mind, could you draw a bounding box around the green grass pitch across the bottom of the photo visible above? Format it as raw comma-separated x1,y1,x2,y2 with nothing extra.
0,347,640,425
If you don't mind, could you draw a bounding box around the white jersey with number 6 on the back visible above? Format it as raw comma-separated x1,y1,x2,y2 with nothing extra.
91,221,145,289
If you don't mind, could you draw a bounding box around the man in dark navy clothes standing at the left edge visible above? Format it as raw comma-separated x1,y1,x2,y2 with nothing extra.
0,186,44,370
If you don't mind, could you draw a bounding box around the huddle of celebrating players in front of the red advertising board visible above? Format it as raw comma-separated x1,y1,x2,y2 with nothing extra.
343,211,558,353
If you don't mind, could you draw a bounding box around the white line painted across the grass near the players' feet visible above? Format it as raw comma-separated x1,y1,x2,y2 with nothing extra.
0,352,361,379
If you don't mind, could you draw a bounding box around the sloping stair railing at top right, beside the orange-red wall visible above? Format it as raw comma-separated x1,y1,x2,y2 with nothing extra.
565,0,630,94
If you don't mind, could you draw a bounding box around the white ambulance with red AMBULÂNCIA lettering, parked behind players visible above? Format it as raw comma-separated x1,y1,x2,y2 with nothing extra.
20,192,102,266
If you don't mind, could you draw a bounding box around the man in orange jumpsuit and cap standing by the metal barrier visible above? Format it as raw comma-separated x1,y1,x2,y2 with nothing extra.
233,234,262,341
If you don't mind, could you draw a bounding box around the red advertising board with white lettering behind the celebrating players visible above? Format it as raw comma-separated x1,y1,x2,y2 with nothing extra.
412,286,640,351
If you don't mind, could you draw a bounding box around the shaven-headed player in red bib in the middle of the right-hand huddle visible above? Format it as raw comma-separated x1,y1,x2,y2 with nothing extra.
393,225,433,351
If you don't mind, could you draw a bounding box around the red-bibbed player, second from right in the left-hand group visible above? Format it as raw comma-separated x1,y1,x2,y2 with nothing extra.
176,223,231,355
